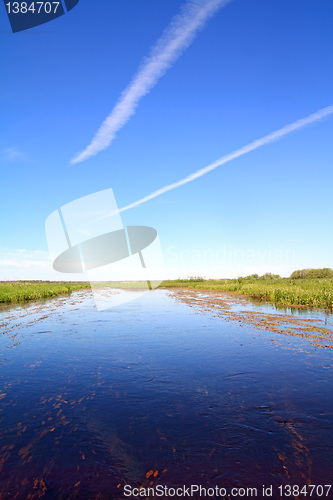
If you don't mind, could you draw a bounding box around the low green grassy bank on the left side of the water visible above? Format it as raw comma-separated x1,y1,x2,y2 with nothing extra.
0,281,90,304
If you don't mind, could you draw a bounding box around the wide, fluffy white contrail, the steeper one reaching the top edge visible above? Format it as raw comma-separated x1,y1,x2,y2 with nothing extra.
71,0,231,163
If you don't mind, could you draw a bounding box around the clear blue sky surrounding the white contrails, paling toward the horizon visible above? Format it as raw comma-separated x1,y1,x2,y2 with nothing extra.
0,0,333,279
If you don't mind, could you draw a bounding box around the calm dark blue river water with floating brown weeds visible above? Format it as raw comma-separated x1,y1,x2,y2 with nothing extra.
0,290,333,500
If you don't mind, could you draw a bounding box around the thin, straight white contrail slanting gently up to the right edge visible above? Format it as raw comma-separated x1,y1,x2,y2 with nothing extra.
119,105,333,212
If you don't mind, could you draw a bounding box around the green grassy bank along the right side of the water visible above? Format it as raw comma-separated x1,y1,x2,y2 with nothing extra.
161,277,333,309
